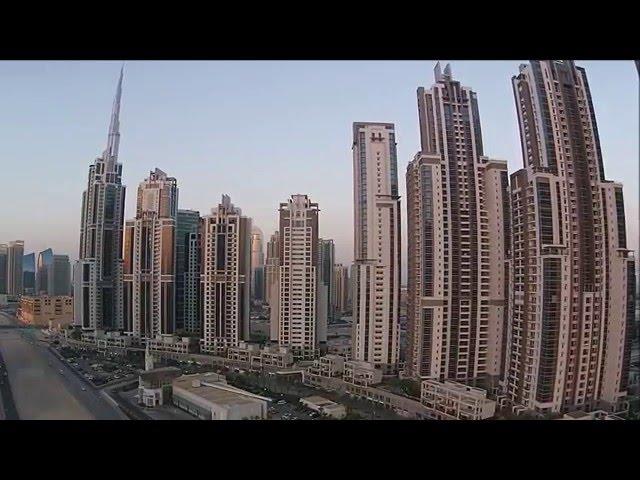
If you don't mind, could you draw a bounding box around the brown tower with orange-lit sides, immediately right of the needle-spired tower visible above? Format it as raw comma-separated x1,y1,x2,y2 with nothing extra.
124,168,178,338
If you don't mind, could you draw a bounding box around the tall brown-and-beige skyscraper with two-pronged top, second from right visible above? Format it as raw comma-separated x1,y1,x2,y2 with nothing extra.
405,63,509,386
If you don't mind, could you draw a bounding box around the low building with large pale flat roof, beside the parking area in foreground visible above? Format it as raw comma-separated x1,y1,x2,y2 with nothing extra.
173,373,271,420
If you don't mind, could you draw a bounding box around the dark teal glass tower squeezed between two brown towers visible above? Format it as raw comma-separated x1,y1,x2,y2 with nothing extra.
176,210,200,334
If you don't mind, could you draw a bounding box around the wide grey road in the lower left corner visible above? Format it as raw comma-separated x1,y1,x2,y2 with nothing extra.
0,312,126,420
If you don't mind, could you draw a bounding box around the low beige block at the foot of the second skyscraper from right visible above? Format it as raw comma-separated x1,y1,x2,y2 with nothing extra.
420,380,496,420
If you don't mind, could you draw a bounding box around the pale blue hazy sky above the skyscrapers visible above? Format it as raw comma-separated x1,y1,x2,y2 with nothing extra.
0,60,638,270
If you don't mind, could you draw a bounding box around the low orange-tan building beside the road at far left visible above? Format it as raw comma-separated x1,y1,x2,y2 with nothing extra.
17,295,73,328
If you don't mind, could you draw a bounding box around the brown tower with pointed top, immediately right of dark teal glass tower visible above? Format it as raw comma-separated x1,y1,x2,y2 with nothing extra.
200,195,251,354
